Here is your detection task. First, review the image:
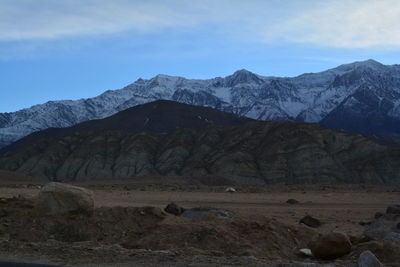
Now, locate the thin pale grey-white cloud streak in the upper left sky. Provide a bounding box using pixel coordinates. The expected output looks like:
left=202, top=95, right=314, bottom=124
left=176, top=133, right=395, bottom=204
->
left=0, top=0, right=193, bottom=41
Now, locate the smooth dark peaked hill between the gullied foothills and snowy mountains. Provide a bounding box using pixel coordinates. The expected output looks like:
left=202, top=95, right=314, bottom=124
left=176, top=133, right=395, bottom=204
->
left=0, top=100, right=253, bottom=154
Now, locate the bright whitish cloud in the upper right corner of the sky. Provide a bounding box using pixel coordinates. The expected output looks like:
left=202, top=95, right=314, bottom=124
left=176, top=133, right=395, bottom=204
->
left=264, top=0, right=400, bottom=48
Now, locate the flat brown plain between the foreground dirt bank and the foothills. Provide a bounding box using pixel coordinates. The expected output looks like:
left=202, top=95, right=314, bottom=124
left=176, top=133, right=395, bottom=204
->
left=0, top=184, right=400, bottom=238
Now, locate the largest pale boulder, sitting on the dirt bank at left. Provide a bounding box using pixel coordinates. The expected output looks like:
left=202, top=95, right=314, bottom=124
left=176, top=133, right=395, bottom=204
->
left=35, top=182, right=94, bottom=216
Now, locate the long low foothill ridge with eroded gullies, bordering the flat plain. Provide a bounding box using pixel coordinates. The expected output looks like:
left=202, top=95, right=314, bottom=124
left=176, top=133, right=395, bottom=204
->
left=0, top=122, right=400, bottom=184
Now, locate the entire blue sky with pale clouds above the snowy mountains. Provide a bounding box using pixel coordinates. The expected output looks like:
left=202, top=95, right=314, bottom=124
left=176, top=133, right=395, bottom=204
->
left=0, top=0, right=400, bottom=112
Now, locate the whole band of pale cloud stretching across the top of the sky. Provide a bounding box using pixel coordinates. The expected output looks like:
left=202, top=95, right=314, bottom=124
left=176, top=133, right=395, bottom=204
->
left=0, top=0, right=400, bottom=48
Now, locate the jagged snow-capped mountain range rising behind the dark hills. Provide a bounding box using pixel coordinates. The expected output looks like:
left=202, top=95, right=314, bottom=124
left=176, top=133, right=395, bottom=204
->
left=0, top=60, right=400, bottom=149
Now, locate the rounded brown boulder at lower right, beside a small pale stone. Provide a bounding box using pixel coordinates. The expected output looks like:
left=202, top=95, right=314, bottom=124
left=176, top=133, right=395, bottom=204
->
left=309, top=232, right=351, bottom=260
